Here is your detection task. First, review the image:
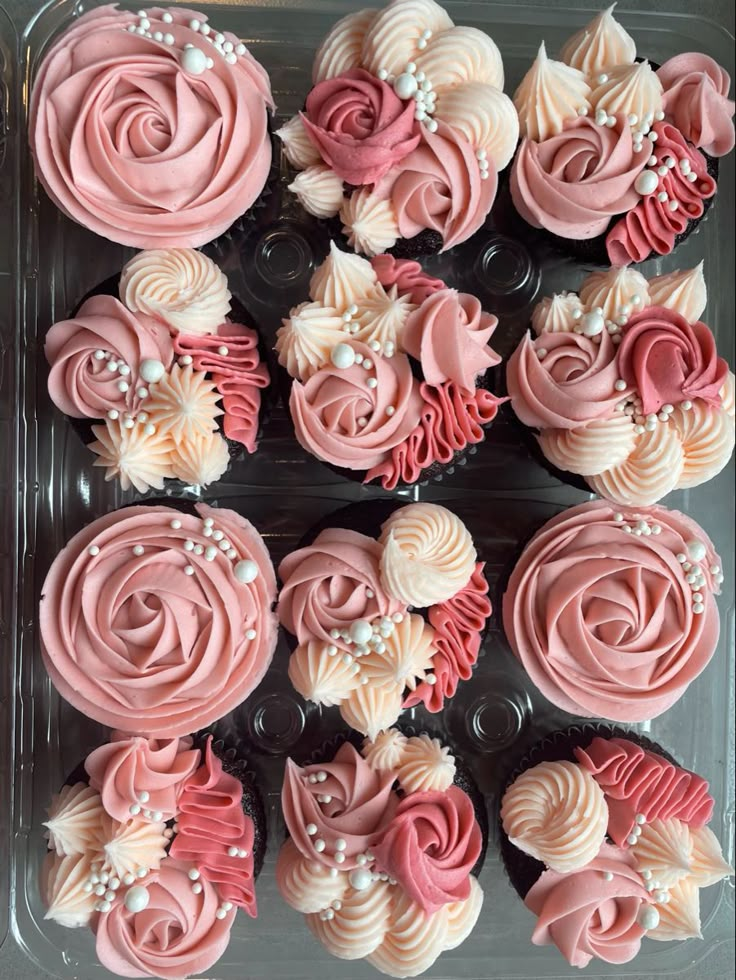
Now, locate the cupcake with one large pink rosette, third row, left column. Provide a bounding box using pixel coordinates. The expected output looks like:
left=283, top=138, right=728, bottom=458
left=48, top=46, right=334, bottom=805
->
left=39, top=504, right=277, bottom=737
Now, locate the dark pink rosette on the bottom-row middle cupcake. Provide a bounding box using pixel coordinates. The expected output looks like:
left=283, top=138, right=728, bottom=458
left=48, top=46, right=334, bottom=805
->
left=371, top=786, right=483, bottom=914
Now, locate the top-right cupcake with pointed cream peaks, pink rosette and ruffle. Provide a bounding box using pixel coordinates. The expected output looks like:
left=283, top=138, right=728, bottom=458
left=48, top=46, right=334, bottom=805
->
left=511, top=5, right=734, bottom=265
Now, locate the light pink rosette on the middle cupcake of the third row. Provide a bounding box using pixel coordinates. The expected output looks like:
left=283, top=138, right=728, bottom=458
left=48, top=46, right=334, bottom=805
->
left=277, top=527, right=406, bottom=644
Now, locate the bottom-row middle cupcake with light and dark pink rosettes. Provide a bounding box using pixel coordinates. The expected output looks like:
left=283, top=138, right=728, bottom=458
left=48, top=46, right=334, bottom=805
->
left=276, top=729, right=487, bottom=977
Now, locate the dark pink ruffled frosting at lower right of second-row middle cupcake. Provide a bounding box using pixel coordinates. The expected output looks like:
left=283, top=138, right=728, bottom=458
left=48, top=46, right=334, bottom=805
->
left=364, top=382, right=506, bottom=490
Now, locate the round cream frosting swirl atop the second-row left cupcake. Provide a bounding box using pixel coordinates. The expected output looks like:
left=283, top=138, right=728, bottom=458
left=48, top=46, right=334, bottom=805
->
left=120, top=248, right=231, bottom=334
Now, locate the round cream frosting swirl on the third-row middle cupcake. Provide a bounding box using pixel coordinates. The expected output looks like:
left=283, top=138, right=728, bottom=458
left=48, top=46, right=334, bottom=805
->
left=379, top=503, right=477, bottom=608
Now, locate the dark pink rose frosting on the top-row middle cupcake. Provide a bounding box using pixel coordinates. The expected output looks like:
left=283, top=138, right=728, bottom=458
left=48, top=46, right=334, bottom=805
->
left=302, top=68, right=419, bottom=185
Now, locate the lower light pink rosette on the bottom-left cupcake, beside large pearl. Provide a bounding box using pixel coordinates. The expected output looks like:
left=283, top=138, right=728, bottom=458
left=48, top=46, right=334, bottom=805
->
left=93, top=858, right=236, bottom=980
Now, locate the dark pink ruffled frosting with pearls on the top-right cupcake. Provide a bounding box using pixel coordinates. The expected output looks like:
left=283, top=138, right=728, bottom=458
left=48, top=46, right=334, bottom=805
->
left=604, top=122, right=716, bottom=265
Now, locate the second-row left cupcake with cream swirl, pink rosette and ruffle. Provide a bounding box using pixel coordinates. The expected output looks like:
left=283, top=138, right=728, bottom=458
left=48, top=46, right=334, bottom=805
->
left=45, top=248, right=270, bottom=493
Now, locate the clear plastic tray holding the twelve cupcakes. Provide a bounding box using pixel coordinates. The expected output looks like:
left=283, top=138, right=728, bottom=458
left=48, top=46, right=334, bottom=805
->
left=8, top=0, right=735, bottom=980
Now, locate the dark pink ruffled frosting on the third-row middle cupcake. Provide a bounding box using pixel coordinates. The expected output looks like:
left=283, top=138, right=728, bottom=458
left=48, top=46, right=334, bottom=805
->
left=404, top=562, right=492, bottom=712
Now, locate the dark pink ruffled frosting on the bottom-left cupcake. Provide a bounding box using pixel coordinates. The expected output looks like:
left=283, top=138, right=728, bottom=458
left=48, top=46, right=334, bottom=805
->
left=169, top=736, right=257, bottom=918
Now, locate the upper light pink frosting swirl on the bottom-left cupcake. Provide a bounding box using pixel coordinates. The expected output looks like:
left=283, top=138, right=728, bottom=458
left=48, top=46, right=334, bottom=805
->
left=84, top=732, right=201, bottom=823
